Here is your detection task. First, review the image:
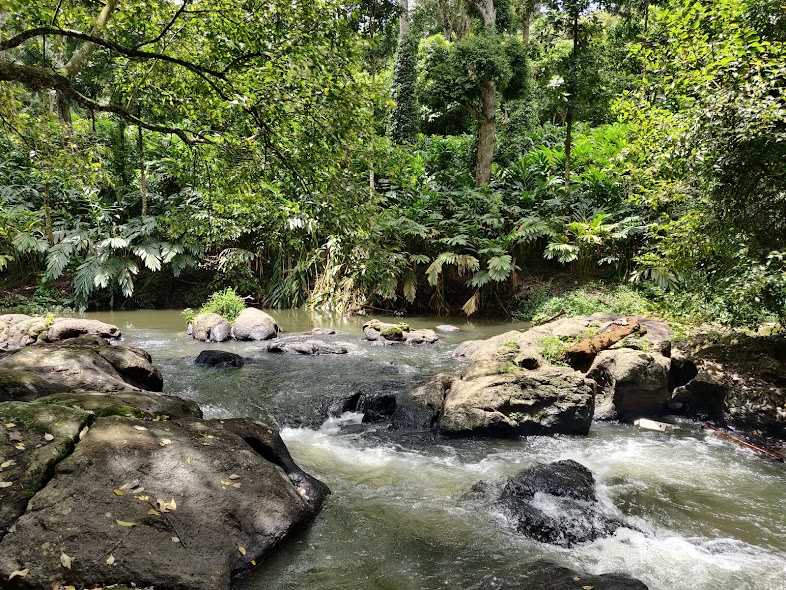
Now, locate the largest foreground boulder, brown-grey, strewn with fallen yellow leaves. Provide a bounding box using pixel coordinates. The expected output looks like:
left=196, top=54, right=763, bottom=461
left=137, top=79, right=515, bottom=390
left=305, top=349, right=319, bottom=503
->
left=0, top=417, right=328, bottom=590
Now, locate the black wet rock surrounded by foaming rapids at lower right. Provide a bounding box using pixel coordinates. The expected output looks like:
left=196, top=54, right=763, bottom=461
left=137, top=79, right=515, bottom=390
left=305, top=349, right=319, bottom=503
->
left=497, top=459, right=621, bottom=547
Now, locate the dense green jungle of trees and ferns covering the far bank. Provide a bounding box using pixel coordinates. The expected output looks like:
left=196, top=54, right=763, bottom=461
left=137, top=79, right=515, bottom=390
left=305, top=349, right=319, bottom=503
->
left=0, top=0, right=786, bottom=325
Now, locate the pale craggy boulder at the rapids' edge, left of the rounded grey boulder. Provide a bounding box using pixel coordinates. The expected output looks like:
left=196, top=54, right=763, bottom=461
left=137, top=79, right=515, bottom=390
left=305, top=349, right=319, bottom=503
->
left=439, top=365, right=595, bottom=436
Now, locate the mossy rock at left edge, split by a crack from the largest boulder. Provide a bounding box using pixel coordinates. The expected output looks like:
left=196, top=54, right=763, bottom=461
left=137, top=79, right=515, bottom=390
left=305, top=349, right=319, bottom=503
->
left=0, top=402, right=91, bottom=540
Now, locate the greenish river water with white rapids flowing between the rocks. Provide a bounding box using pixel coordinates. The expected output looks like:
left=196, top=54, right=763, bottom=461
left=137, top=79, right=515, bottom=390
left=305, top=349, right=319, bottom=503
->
left=89, top=311, right=786, bottom=590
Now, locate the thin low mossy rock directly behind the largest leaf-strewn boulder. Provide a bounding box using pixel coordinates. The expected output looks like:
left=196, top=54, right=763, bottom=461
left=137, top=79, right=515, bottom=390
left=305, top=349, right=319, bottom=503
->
left=35, top=391, right=202, bottom=420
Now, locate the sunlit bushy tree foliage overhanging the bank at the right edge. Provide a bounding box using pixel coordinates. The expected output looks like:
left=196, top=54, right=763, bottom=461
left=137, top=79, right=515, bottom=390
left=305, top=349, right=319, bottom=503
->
left=619, top=0, right=786, bottom=325
